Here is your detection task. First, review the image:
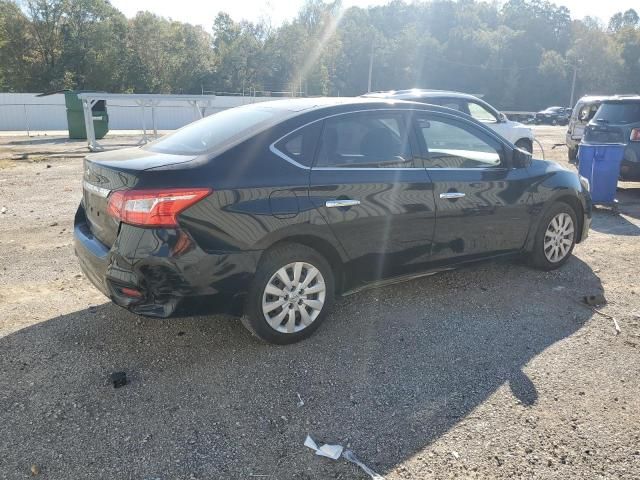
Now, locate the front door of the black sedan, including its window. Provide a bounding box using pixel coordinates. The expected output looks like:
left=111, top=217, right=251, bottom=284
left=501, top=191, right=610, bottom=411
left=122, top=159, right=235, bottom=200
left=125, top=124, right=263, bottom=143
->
left=415, top=113, right=531, bottom=261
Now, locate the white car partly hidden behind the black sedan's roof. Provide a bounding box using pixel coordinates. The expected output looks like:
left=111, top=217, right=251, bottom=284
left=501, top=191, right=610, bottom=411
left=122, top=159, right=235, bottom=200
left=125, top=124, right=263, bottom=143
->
left=363, top=88, right=534, bottom=153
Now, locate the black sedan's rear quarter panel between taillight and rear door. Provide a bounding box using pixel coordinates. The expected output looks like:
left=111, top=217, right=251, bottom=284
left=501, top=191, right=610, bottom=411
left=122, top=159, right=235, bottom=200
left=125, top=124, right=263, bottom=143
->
left=175, top=125, right=343, bottom=257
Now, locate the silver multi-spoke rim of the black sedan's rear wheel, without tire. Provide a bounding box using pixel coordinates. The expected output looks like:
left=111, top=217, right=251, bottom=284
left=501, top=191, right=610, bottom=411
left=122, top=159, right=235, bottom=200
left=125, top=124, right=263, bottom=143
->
left=262, top=262, right=327, bottom=333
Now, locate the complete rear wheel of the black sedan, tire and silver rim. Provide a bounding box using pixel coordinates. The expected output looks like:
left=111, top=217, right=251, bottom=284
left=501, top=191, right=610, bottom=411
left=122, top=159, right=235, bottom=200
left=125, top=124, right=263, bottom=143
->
left=242, top=243, right=335, bottom=345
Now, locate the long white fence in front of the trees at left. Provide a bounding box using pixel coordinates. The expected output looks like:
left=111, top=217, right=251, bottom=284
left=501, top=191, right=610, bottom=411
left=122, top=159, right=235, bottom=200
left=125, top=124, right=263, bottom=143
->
left=0, top=93, right=290, bottom=133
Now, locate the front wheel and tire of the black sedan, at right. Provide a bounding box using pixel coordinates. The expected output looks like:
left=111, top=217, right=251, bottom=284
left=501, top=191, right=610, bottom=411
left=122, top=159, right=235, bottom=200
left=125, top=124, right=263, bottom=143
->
left=529, top=202, right=578, bottom=270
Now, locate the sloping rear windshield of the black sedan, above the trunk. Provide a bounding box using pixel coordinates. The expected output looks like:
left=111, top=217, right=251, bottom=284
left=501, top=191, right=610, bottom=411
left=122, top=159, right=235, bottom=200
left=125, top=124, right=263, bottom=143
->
left=144, top=105, right=282, bottom=155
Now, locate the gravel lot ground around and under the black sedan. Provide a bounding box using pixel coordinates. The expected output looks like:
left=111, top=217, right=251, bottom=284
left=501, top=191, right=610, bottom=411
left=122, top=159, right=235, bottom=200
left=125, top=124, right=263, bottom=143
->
left=0, top=127, right=640, bottom=480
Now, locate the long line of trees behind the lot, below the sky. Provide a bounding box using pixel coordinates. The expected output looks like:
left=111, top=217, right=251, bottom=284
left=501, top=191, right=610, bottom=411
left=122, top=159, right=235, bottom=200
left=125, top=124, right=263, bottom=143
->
left=0, top=0, right=640, bottom=110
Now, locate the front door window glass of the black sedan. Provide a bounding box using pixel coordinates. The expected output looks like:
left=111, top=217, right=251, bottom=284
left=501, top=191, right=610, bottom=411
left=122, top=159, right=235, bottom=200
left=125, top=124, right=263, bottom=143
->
left=418, top=118, right=501, bottom=168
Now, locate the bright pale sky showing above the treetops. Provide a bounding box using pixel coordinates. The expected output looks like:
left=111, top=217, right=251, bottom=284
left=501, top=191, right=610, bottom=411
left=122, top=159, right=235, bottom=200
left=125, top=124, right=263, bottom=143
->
left=111, top=0, right=638, bottom=30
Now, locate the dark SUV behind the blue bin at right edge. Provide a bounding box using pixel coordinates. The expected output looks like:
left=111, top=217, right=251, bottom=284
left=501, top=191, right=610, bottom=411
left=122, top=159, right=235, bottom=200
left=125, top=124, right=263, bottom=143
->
left=582, top=95, right=640, bottom=181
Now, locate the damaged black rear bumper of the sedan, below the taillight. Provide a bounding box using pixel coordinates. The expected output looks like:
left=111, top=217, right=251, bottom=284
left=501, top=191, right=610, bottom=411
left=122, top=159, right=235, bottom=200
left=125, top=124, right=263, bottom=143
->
left=74, top=206, right=260, bottom=318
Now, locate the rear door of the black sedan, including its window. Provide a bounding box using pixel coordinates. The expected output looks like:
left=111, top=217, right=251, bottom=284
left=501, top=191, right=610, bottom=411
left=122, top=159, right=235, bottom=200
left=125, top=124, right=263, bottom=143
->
left=309, top=110, right=435, bottom=281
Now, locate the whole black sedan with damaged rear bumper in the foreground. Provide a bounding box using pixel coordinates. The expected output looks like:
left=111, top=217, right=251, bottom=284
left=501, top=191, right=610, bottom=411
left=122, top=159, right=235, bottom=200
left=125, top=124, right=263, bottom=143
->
left=75, top=98, right=591, bottom=344
